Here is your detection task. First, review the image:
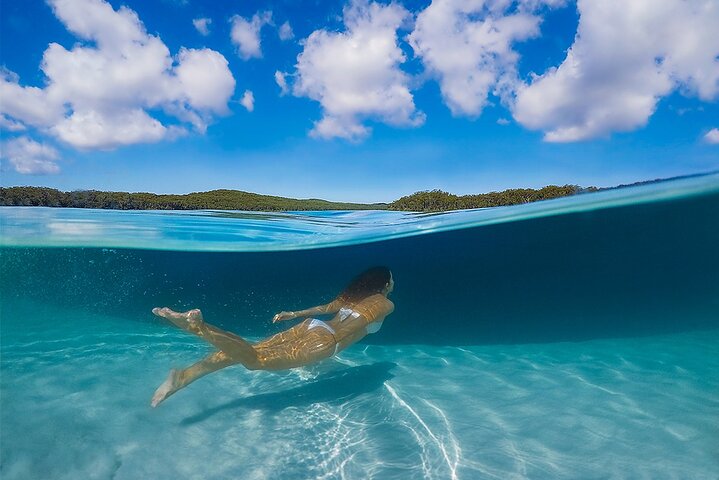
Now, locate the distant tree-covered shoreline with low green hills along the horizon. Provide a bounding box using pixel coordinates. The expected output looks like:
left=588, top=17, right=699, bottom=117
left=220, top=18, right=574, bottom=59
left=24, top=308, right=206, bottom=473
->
left=0, top=175, right=701, bottom=212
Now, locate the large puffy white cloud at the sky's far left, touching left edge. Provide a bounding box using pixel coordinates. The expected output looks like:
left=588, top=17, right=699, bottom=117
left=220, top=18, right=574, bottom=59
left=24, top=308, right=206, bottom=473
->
left=0, top=0, right=235, bottom=149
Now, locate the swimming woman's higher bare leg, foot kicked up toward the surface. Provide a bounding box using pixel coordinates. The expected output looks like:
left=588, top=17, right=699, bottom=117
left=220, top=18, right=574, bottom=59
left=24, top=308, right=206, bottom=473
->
left=152, top=307, right=259, bottom=370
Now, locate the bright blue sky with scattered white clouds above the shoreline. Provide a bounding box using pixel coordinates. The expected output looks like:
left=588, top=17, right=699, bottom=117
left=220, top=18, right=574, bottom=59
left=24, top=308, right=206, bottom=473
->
left=0, top=0, right=719, bottom=202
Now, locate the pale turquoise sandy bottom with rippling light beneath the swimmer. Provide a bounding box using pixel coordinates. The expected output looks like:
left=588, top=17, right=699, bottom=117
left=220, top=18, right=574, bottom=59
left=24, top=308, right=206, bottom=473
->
left=0, top=306, right=719, bottom=479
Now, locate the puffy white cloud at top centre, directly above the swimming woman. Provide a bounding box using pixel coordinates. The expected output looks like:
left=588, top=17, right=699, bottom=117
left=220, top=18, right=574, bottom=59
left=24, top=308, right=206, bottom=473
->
left=292, top=0, right=425, bottom=141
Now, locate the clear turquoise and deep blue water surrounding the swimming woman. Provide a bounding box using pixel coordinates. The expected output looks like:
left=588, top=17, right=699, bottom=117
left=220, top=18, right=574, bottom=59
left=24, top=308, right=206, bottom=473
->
left=0, top=175, right=719, bottom=479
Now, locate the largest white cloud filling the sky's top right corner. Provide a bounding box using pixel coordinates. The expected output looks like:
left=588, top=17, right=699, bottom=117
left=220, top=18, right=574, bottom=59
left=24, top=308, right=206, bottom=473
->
left=512, top=0, right=719, bottom=142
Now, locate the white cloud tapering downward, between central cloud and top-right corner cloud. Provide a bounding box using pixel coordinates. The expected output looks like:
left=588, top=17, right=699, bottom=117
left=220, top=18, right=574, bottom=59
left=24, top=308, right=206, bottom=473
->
left=409, top=0, right=544, bottom=117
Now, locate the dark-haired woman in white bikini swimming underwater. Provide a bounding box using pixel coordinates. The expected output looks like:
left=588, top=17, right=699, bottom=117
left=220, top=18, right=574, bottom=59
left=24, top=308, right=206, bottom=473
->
left=151, top=267, right=394, bottom=407
